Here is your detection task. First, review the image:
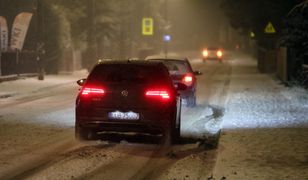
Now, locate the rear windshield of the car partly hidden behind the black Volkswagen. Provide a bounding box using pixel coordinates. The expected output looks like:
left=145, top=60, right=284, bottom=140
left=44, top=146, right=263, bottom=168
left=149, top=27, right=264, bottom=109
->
left=151, top=59, right=191, bottom=75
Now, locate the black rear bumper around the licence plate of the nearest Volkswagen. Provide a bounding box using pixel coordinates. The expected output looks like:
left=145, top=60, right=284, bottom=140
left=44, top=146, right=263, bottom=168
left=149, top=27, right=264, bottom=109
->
left=75, top=100, right=179, bottom=134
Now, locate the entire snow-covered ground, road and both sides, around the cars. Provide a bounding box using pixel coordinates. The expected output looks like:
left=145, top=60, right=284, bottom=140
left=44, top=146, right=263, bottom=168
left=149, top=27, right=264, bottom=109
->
left=0, top=51, right=308, bottom=180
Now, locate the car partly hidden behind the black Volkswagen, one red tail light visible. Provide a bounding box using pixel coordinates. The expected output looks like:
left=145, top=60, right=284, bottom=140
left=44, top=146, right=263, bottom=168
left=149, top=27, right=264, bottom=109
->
left=147, top=58, right=202, bottom=107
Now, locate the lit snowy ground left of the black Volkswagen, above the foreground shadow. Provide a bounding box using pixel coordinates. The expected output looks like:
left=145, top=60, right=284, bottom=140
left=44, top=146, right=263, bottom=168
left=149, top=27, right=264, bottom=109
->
left=0, top=70, right=88, bottom=128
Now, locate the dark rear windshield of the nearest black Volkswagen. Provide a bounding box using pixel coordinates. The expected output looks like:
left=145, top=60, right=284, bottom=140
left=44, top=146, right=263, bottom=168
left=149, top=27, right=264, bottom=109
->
left=88, top=64, right=168, bottom=84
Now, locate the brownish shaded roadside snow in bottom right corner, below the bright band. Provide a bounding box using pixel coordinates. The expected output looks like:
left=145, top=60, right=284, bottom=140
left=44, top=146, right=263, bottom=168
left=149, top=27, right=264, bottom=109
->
left=214, top=128, right=308, bottom=180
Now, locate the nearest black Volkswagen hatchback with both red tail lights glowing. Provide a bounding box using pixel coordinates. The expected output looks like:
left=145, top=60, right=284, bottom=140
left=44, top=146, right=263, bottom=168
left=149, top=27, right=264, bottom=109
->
left=75, top=60, right=186, bottom=142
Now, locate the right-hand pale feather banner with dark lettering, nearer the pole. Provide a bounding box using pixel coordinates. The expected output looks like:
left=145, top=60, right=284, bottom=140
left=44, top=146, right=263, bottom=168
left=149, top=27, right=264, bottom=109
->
left=10, top=12, right=33, bottom=51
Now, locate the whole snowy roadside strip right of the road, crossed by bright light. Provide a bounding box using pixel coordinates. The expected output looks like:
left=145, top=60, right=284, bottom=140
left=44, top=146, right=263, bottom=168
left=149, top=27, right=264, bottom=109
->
left=214, top=54, right=308, bottom=180
